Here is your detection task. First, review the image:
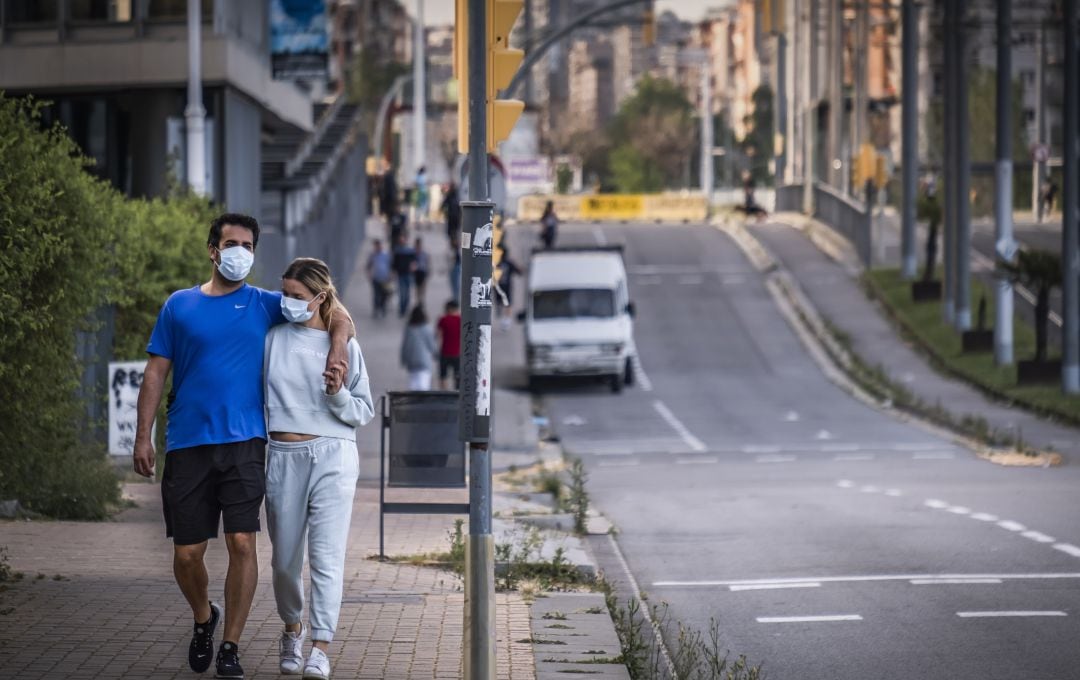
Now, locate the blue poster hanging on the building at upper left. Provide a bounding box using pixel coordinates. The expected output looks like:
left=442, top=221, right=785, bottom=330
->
left=270, top=0, right=329, bottom=80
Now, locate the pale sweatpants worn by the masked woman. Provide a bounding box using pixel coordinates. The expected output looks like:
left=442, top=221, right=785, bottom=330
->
left=266, top=437, right=360, bottom=642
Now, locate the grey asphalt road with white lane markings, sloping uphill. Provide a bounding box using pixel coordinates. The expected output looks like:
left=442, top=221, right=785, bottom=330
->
left=503, top=225, right=1080, bottom=680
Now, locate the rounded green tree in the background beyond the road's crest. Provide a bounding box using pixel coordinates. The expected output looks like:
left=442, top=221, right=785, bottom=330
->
left=608, top=77, right=694, bottom=193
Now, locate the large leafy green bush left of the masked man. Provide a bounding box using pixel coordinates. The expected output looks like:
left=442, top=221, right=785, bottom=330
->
left=0, top=93, right=217, bottom=519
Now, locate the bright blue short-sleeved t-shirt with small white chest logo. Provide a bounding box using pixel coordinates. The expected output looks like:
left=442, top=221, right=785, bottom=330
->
left=146, top=284, right=285, bottom=451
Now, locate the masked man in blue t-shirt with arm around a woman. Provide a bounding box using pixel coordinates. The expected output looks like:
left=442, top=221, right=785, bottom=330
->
left=134, top=214, right=352, bottom=678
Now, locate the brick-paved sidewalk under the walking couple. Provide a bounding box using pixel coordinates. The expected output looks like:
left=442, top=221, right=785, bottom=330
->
left=0, top=222, right=536, bottom=680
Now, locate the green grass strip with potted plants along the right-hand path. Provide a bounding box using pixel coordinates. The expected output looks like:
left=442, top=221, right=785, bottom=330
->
left=864, top=269, right=1080, bottom=425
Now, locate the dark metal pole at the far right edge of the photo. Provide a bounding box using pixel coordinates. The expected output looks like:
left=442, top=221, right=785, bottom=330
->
left=1062, top=0, right=1080, bottom=394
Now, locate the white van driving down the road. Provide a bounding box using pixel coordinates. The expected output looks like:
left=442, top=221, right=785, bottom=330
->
left=524, top=247, right=637, bottom=392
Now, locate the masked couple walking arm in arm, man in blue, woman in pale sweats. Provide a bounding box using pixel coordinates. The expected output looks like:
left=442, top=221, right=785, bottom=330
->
left=134, top=214, right=374, bottom=679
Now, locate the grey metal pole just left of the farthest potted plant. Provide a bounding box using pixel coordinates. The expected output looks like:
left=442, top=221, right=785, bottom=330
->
left=900, top=0, right=919, bottom=281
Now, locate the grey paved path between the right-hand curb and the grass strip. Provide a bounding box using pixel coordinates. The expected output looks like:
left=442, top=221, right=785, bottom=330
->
left=747, top=214, right=1080, bottom=460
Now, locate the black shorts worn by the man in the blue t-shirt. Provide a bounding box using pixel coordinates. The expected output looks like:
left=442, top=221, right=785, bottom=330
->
left=161, top=438, right=267, bottom=545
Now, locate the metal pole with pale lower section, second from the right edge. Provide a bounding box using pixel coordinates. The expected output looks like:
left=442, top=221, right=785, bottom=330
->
left=994, top=0, right=1015, bottom=366
